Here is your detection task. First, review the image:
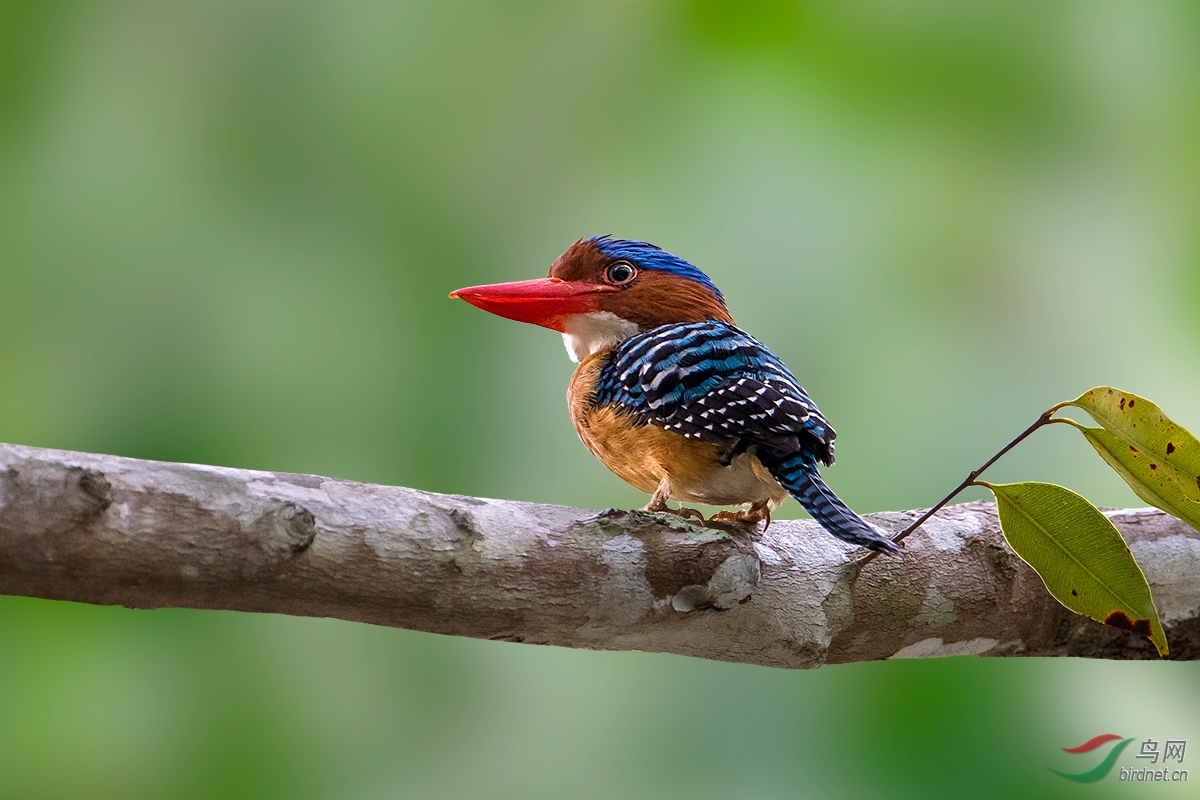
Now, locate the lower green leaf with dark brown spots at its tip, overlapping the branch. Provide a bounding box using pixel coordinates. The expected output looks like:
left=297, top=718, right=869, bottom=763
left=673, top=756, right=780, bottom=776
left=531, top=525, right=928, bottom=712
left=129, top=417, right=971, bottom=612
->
left=980, top=481, right=1166, bottom=656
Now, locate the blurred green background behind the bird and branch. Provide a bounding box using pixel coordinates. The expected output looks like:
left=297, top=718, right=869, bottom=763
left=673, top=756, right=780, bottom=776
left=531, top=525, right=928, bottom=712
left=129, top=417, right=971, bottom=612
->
left=0, top=0, right=1200, bottom=799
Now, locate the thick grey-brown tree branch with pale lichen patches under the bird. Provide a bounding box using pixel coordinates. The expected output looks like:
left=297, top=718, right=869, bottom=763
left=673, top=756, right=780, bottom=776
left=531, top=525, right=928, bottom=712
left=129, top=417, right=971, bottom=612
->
left=0, top=445, right=1200, bottom=667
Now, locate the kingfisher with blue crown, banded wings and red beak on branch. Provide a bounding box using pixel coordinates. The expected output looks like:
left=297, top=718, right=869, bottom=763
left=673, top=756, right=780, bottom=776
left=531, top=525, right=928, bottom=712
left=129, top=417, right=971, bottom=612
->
left=450, top=235, right=904, bottom=553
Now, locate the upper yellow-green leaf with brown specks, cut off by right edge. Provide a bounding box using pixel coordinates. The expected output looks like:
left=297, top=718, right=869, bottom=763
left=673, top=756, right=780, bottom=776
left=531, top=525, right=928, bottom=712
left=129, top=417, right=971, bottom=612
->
left=1060, top=386, right=1200, bottom=530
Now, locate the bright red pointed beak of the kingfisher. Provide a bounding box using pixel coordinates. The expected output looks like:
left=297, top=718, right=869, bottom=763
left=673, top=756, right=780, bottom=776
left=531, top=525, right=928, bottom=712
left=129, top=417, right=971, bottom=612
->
left=450, top=278, right=617, bottom=332
